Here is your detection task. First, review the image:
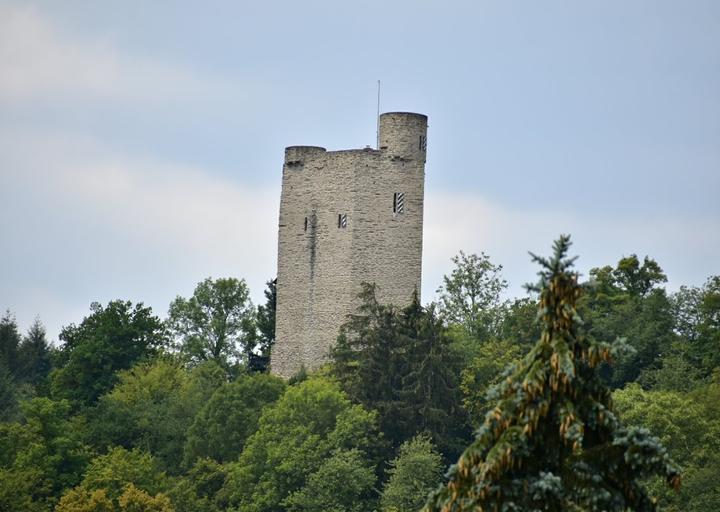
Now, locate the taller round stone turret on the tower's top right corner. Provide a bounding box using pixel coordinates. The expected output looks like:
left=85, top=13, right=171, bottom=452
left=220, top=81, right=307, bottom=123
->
left=379, top=112, right=427, bottom=162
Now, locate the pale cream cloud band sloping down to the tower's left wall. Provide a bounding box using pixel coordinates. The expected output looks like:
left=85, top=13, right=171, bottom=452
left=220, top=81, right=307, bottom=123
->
left=0, top=129, right=279, bottom=267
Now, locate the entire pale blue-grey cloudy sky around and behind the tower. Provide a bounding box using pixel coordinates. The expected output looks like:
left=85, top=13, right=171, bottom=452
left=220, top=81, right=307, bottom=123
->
left=0, top=0, right=720, bottom=338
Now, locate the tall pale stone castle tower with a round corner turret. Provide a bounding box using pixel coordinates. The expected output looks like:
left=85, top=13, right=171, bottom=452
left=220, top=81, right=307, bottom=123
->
left=271, top=112, right=427, bottom=378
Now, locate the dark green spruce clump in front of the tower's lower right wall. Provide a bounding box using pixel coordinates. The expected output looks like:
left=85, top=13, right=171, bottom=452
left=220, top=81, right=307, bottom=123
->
left=332, top=284, right=468, bottom=457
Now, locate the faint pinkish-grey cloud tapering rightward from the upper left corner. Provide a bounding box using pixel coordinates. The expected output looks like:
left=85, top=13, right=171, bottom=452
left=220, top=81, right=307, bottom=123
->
left=0, top=5, right=246, bottom=102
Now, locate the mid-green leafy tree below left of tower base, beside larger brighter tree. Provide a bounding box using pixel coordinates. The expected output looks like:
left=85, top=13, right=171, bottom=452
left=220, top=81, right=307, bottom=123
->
left=185, top=374, right=285, bottom=466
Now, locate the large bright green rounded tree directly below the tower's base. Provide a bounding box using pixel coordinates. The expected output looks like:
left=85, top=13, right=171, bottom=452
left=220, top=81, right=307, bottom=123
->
left=221, top=377, right=381, bottom=512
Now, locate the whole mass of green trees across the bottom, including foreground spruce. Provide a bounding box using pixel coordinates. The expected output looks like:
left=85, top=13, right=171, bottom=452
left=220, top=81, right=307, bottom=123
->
left=0, top=241, right=720, bottom=512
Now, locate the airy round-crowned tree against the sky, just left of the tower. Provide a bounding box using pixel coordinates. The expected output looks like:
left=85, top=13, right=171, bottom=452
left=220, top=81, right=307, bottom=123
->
left=168, top=278, right=256, bottom=368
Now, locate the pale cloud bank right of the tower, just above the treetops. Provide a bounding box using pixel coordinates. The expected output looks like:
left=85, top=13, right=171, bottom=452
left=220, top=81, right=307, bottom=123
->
left=423, top=191, right=720, bottom=301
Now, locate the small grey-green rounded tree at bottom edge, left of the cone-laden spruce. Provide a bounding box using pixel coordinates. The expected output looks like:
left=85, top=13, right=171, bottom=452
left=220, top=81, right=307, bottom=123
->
left=380, top=435, right=443, bottom=512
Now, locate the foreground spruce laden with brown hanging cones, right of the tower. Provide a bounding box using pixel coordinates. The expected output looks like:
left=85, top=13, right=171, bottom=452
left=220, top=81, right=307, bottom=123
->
left=424, top=236, right=681, bottom=512
